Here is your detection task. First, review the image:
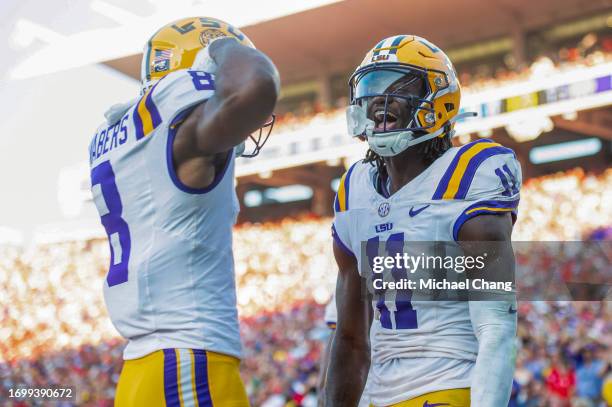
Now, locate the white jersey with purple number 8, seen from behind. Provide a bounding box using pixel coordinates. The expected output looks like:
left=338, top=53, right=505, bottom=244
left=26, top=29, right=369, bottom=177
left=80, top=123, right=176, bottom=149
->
left=89, top=70, right=241, bottom=359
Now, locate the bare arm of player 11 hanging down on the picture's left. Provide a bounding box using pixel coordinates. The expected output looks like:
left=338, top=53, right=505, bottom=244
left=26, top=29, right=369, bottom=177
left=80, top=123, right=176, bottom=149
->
left=325, top=242, right=371, bottom=407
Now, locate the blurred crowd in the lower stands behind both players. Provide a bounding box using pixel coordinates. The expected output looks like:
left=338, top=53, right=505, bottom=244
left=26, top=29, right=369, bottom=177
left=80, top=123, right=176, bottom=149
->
left=0, top=169, right=612, bottom=407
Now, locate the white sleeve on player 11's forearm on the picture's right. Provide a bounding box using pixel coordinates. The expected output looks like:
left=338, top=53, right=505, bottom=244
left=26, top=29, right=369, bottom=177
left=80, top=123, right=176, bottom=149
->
left=470, top=301, right=516, bottom=407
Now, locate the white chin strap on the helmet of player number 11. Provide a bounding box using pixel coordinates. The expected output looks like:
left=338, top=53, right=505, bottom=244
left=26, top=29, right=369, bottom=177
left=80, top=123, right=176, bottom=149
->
left=365, top=112, right=477, bottom=157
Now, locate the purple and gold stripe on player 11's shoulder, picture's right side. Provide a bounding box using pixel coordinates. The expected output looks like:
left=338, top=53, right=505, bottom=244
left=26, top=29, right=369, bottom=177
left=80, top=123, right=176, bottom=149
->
left=432, top=139, right=514, bottom=200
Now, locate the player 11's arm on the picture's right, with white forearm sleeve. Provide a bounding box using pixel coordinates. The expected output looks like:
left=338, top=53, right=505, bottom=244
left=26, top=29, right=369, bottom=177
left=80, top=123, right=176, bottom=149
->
left=458, top=213, right=517, bottom=407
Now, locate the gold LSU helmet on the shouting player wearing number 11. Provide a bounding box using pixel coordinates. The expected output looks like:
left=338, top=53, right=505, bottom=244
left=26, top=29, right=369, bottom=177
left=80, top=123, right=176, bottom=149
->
left=347, top=35, right=473, bottom=157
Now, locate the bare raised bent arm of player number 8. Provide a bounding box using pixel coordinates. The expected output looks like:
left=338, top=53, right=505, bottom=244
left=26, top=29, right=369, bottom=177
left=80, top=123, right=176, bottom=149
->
left=178, top=37, right=280, bottom=155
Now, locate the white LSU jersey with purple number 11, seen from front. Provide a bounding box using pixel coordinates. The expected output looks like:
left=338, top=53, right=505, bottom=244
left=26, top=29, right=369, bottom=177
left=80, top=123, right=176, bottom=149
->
left=332, top=139, right=521, bottom=405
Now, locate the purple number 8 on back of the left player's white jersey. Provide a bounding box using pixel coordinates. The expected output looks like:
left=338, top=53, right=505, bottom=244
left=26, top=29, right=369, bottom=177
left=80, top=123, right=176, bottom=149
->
left=91, top=161, right=132, bottom=287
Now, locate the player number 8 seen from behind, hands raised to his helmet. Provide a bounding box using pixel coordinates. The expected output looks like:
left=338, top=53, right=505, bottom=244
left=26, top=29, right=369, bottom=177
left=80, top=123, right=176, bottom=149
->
left=89, top=17, right=279, bottom=407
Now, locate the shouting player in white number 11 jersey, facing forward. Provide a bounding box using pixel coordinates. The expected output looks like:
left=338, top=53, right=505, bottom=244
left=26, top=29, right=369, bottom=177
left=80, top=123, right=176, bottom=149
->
left=326, top=35, right=521, bottom=407
